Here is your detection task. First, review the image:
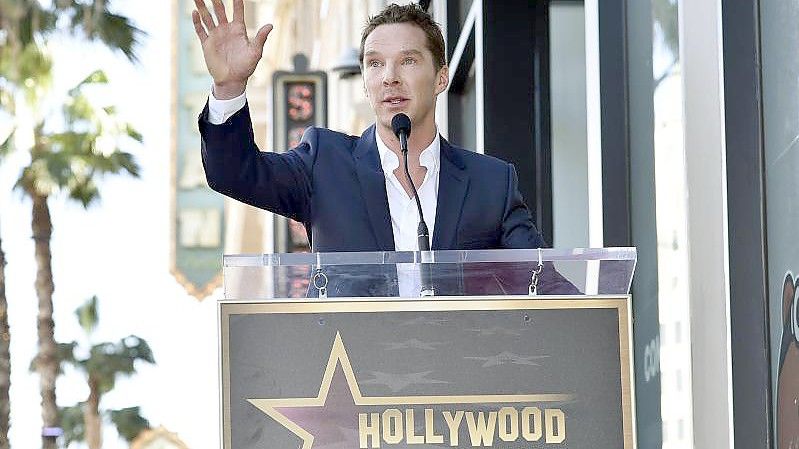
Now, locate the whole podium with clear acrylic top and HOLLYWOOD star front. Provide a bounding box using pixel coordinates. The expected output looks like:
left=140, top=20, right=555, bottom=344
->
left=219, top=248, right=636, bottom=449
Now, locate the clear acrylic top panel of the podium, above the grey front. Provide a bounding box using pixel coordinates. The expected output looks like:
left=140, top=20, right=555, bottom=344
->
left=223, top=248, right=636, bottom=300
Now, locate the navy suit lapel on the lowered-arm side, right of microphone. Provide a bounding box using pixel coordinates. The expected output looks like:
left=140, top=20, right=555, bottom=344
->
left=432, top=137, right=469, bottom=250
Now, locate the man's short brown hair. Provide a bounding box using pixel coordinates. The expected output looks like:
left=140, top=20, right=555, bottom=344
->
left=358, top=3, right=447, bottom=71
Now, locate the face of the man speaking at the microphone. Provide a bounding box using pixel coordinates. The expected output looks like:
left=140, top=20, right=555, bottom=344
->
left=363, top=23, right=449, bottom=134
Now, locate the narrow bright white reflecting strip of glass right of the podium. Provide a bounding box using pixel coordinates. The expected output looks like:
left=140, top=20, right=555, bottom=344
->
left=652, top=0, right=693, bottom=449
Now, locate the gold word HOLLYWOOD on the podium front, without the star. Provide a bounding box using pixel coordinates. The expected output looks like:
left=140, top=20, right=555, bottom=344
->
left=358, top=407, right=566, bottom=449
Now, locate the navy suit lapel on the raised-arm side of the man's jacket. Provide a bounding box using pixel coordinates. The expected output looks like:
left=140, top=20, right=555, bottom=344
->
left=353, top=125, right=394, bottom=251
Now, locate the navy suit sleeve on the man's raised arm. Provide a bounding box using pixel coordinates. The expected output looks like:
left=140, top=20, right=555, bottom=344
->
left=199, top=100, right=318, bottom=224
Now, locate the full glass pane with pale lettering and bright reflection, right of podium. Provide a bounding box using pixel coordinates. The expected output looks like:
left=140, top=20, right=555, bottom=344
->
left=626, top=0, right=692, bottom=449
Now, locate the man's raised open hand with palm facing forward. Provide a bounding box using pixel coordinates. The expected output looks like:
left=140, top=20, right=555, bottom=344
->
left=191, top=0, right=272, bottom=99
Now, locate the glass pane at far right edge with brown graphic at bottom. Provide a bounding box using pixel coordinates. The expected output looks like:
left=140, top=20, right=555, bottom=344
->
left=760, top=1, right=799, bottom=449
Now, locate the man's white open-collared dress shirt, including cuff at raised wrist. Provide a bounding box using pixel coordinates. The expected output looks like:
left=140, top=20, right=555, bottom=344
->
left=208, top=91, right=441, bottom=297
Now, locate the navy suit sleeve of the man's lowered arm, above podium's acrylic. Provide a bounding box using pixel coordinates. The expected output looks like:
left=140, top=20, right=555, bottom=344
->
left=501, top=164, right=547, bottom=249
